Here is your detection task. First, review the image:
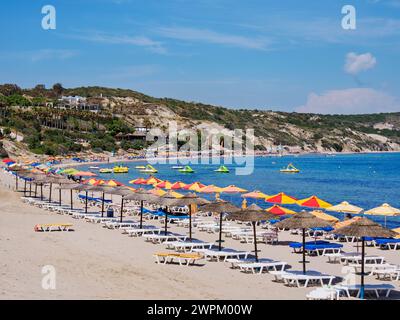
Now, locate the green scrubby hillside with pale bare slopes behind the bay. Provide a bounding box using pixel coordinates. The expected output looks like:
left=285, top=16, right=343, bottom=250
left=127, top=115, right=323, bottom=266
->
left=0, top=84, right=400, bottom=154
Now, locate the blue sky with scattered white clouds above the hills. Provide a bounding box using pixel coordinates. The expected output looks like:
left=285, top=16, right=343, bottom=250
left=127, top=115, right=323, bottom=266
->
left=0, top=0, right=400, bottom=113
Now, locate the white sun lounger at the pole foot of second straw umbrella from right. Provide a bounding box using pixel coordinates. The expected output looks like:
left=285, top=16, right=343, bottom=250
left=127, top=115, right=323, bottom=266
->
left=270, top=271, right=335, bottom=288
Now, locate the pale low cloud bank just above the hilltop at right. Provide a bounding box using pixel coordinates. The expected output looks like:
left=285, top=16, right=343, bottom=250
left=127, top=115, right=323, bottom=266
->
left=296, top=88, right=400, bottom=114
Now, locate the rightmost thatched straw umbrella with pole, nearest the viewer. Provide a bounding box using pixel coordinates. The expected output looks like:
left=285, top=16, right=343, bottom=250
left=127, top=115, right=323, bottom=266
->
left=332, top=218, right=397, bottom=299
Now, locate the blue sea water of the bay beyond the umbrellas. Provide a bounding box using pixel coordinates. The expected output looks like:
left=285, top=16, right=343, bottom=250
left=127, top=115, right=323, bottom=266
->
left=78, top=153, right=400, bottom=228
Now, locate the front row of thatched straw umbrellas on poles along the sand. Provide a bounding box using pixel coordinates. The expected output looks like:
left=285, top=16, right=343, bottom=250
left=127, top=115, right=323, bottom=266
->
left=6, top=168, right=397, bottom=298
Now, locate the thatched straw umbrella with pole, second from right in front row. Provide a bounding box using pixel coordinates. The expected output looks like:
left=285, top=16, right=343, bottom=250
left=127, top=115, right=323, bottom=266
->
left=274, top=211, right=332, bottom=273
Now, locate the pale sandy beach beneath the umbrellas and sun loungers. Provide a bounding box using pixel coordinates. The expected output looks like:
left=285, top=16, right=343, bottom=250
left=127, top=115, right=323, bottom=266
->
left=0, top=171, right=400, bottom=299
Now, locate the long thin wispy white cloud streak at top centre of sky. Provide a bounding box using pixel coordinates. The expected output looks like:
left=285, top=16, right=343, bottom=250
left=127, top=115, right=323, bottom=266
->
left=157, top=27, right=270, bottom=50
